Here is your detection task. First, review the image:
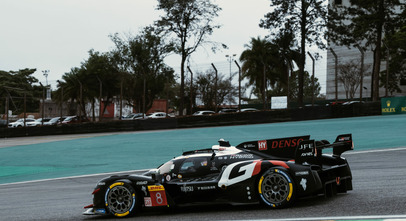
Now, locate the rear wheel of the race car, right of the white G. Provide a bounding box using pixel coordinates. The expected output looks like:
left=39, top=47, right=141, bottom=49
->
left=258, top=168, right=295, bottom=208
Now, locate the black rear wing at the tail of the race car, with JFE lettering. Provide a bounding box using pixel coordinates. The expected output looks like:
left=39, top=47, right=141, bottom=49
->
left=295, top=134, right=354, bottom=164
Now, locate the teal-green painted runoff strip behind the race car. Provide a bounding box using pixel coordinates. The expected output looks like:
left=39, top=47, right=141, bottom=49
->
left=0, top=115, right=406, bottom=184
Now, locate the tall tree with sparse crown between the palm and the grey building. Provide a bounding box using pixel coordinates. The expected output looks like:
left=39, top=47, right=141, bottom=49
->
left=260, top=0, right=327, bottom=106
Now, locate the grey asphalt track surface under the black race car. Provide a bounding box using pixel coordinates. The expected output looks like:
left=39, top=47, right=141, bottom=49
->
left=0, top=148, right=406, bottom=221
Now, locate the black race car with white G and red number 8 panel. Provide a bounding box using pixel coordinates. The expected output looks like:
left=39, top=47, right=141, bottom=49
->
left=84, top=134, right=353, bottom=217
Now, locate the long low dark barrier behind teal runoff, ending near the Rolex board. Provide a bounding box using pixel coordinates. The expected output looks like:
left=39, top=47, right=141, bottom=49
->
left=0, top=102, right=381, bottom=138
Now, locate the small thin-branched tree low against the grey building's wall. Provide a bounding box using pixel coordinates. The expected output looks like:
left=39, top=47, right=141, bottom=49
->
left=338, top=60, right=369, bottom=99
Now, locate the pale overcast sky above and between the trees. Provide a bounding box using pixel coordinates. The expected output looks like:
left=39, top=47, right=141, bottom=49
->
left=0, top=0, right=326, bottom=93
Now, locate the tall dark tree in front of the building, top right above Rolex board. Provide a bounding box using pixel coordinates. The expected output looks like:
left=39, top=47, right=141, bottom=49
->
left=328, top=0, right=404, bottom=101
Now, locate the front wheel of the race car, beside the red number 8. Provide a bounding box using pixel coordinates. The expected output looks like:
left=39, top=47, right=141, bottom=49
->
left=105, top=181, right=138, bottom=217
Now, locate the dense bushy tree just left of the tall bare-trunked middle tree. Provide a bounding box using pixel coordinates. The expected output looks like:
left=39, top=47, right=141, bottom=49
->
left=111, top=26, right=174, bottom=113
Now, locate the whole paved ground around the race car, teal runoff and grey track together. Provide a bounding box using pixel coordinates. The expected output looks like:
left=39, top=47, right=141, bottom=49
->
left=0, top=115, right=406, bottom=220
